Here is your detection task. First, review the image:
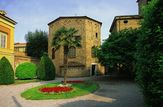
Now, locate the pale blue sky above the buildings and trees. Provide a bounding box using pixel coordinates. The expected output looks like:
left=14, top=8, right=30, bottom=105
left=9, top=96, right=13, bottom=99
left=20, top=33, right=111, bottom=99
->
left=0, top=0, right=138, bottom=42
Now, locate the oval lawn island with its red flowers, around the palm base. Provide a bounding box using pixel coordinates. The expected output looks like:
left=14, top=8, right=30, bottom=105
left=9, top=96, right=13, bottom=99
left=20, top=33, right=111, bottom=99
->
left=21, top=81, right=99, bottom=100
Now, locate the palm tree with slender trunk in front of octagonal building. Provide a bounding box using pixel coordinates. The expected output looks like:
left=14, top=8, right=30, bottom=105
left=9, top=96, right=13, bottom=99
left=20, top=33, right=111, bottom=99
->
left=52, top=27, right=81, bottom=84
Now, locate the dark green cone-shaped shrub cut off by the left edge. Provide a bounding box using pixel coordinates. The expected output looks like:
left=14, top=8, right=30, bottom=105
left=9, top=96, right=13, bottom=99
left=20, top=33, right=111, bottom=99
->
left=0, top=57, right=15, bottom=84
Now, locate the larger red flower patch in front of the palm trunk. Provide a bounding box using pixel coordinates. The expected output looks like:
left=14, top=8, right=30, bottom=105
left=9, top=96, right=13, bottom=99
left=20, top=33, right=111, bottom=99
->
left=39, top=86, right=73, bottom=93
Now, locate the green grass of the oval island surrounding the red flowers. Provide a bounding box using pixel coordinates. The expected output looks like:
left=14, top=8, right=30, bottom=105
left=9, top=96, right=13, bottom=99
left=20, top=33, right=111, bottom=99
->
left=21, top=82, right=99, bottom=100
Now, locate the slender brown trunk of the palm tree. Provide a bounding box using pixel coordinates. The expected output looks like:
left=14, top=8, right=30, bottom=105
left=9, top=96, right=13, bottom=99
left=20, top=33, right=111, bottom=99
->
left=63, top=46, right=68, bottom=84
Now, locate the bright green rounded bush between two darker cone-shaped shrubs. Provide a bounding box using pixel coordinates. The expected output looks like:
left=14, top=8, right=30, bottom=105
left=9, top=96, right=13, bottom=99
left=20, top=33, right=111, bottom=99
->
left=15, top=62, right=37, bottom=79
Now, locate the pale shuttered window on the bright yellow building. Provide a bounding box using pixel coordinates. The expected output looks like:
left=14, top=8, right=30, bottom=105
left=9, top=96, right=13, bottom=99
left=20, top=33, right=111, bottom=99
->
left=0, top=32, right=7, bottom=48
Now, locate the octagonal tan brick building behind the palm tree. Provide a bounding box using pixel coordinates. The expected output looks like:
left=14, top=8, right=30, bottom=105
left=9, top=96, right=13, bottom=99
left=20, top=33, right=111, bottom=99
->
left=48, top=16, right=104, bottom=77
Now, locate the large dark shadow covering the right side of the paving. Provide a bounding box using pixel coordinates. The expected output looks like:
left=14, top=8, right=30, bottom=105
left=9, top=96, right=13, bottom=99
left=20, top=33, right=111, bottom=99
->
left=61, top=77, right=144, bottom=107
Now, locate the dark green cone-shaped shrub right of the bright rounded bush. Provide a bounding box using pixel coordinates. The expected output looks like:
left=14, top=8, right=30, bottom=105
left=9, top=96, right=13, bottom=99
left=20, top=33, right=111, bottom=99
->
left=37, top=53, right=55, bottom=80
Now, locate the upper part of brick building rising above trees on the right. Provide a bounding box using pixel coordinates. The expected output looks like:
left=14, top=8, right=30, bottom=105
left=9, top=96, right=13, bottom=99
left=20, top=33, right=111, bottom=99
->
left=110, top=15, right=142, bottom=32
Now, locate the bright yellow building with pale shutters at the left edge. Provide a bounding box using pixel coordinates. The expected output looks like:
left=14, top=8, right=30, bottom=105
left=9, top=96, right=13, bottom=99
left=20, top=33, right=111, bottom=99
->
left=0, top=11, right=16, bottom=66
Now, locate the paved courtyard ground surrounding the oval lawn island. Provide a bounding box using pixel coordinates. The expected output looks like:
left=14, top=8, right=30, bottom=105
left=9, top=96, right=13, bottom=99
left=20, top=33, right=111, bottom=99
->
left=0, top=78, right=143, bottom=107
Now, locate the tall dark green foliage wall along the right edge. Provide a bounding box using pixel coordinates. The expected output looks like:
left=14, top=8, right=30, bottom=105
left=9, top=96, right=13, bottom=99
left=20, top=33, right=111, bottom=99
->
left=136, top=0, right=163, bottom=107
